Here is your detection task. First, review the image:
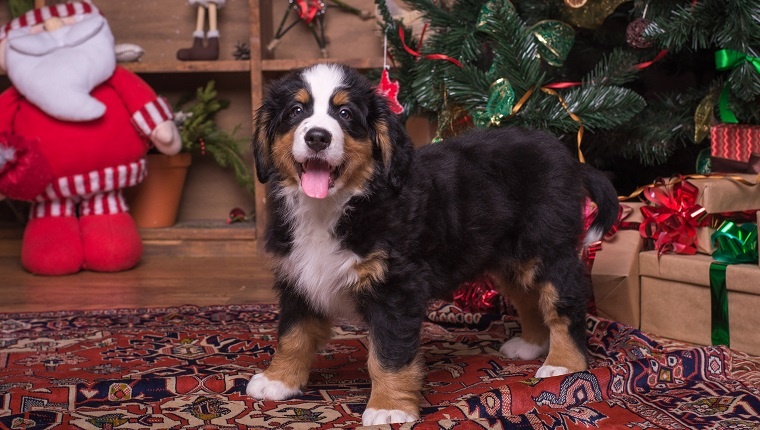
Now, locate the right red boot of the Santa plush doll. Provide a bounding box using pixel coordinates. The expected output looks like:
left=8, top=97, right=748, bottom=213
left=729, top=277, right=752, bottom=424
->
left=79, top=212, right=142, bottom=272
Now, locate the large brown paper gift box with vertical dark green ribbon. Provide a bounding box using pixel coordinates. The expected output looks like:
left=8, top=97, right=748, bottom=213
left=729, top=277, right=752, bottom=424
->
left=639, top=251, right=760, bottom=355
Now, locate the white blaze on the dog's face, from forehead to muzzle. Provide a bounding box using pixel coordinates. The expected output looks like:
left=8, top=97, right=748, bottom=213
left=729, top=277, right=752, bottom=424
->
left=293, top=64, right=344, bottom=167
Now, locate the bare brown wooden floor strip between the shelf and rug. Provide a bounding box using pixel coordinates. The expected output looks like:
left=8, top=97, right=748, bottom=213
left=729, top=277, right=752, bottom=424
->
left=0, top=255, right=276, bottom=312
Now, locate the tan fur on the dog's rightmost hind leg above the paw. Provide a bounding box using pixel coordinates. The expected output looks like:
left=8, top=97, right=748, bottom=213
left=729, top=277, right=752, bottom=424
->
left=538, top=282, right=588, bottom=372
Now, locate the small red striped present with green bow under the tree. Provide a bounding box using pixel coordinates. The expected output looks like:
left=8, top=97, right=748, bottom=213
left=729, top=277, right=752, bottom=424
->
left=710, top=124, right=760, bottom=166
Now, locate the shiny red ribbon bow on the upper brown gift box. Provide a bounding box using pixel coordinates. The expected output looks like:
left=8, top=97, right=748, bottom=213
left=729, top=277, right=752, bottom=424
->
left=639, top=178, right=707, bottom=255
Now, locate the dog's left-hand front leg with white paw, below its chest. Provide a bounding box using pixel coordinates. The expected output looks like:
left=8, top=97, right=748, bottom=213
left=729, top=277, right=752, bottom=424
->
left=245, top=293, right=331, bottom=400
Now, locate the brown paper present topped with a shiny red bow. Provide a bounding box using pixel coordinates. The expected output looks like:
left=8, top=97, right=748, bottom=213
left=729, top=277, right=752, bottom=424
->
left=640, top=173, right=760, bottom=255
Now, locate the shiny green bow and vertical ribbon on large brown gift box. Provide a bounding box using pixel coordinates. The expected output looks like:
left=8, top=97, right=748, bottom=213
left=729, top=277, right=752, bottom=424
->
left=710, top=221, right=758, bottom=346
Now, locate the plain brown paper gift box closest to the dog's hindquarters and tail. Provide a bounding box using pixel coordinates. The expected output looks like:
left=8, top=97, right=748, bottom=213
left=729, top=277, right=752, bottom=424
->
left=591, top=202, right=643, bottom=328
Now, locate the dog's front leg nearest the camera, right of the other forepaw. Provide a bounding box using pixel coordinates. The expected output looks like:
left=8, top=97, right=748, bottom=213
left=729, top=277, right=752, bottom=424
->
left=362, top=304, right=424, bottom=425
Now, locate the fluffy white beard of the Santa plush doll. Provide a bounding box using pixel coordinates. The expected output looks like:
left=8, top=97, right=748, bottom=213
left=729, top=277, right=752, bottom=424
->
left=6, top=16, right=116, bottom=121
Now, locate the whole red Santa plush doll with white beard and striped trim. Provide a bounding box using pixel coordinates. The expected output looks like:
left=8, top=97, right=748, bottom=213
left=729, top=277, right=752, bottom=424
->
left=0, top=2, right=181, bottom=275
